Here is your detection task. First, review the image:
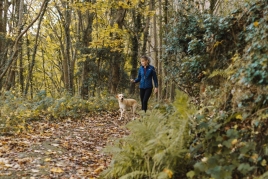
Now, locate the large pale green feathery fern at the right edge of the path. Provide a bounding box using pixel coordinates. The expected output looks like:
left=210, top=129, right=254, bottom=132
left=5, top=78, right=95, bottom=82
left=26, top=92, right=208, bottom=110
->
left=101, top=91, right=195, bottom=178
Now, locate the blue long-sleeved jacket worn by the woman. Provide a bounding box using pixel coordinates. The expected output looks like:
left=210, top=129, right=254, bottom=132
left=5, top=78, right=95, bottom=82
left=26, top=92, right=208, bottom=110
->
left=135, top=65, right=158, bottom=89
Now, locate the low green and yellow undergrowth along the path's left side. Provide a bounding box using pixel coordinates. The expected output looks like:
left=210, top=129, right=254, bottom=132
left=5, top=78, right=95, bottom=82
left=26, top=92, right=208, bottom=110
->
left=0, top=91, right=118, bottom=134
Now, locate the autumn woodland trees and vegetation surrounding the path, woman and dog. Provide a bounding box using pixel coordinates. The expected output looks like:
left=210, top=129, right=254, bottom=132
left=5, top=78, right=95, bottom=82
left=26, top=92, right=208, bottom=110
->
left=0, top=0, right=268, bottom=179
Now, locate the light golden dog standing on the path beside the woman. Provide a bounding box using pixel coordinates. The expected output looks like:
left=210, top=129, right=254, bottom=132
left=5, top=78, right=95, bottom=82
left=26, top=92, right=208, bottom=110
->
left=116, top=94, right=138, bottom=120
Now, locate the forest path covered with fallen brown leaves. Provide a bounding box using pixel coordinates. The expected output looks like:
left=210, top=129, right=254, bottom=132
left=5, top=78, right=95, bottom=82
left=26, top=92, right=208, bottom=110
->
left=0, top=112, right=128, bottom=179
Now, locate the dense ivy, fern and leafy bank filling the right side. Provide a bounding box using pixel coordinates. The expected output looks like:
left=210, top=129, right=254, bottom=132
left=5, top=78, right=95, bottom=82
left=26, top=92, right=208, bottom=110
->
left=103, top=1, right=268, bottom=179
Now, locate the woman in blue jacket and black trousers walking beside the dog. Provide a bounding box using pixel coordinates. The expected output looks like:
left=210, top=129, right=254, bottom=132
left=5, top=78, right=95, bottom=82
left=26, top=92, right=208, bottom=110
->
left=131, top=56, right=158, bottom=112
